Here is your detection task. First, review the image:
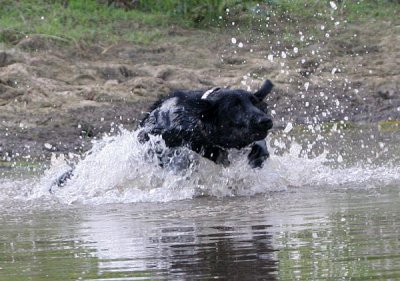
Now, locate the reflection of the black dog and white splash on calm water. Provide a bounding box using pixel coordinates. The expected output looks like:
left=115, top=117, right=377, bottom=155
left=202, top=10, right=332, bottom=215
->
left=71, top=199, right=277, bottom=280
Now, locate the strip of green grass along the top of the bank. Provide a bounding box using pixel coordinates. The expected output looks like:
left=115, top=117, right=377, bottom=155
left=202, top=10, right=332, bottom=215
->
left=0, top=0, right=400, bottom=44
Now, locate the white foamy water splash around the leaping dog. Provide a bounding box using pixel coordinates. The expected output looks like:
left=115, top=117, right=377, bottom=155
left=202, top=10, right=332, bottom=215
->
left=0, top=126, right=400, bottom=205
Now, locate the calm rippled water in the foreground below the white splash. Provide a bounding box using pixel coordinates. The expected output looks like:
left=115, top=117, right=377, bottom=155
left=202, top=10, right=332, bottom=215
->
left=0, top=186, right=400, bottom=280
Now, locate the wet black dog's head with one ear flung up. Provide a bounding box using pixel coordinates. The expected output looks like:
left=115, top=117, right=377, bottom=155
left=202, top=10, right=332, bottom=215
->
left=201, top=80, right=273, bottom=148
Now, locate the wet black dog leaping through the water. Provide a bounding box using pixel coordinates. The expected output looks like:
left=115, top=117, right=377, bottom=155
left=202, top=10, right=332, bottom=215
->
left=139, top=77, right=273, bottom=168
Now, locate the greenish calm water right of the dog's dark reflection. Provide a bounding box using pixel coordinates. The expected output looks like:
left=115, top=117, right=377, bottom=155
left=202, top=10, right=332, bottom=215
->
left=276, top=185, right=400, bottom=280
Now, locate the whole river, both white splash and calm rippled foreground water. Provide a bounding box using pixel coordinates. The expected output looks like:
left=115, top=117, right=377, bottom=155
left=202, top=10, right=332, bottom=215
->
left=0, top=124, right=400, bottom=280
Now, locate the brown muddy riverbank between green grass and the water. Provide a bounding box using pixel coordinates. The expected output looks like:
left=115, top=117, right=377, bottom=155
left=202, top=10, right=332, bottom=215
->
left=0, top=22, right=400, bottom=161
